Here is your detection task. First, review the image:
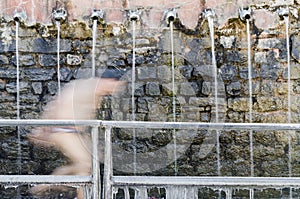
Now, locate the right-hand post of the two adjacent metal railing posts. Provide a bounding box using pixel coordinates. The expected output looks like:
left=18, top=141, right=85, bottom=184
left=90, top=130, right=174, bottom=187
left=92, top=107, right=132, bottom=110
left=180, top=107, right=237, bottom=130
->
left=104, top=126, right=113, bottom=199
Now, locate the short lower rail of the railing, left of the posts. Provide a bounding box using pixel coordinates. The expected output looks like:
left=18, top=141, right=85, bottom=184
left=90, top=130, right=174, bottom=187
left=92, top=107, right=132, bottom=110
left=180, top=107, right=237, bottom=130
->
left=0, top=175, right=92, bottom=184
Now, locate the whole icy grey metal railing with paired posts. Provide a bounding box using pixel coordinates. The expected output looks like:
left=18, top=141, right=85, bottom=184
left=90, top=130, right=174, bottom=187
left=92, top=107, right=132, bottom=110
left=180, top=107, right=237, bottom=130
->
left=0, top=119, right=300, bottom=199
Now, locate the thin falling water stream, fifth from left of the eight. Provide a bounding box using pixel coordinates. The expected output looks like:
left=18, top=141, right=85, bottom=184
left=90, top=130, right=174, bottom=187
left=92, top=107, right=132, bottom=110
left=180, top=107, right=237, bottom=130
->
left=170, top=20, right=177, bottom=175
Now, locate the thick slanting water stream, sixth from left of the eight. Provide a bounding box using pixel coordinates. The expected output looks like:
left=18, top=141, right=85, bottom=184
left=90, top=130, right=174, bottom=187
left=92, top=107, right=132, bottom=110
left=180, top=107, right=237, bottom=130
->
left=207, top=16, right=221, bottom=175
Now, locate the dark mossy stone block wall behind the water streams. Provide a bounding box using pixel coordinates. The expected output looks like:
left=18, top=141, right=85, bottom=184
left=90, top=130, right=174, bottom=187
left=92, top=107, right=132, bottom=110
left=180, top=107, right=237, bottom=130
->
left=0, top=1, right=300, bottom=197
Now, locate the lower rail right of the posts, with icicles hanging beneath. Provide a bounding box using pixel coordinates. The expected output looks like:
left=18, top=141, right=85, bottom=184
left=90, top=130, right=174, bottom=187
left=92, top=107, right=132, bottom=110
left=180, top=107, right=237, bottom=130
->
left=112, top=176, right=300, bottom=188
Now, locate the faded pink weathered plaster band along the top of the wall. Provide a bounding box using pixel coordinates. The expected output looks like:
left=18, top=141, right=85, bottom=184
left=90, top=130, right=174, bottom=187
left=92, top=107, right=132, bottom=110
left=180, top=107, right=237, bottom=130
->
left=0, top=0, right=299, bottom=28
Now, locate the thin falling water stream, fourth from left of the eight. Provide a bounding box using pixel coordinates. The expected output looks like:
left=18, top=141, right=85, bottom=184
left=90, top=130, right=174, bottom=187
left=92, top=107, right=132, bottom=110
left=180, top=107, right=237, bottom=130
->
left=131, top=20, right=137, bottom=174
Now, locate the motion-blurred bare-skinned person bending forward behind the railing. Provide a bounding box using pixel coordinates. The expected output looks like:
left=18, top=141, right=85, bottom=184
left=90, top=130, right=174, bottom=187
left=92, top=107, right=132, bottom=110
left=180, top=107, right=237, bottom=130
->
left=29, top=78, right=124, bottom=199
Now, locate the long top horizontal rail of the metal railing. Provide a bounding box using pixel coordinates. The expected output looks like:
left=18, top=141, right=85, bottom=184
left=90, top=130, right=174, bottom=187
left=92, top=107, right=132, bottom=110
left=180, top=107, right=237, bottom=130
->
left=0, top=119, right=300, bottom=131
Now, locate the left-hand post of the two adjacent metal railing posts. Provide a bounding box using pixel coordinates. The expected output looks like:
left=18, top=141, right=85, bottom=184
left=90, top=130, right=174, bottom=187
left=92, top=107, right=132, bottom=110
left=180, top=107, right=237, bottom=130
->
left=92, top=126, right=101, bottom=199
